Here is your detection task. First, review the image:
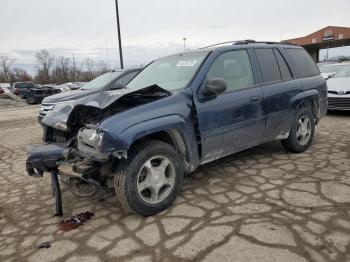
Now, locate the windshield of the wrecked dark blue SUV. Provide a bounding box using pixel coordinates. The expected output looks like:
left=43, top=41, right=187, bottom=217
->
left=127, top=52, right=208, bottom=91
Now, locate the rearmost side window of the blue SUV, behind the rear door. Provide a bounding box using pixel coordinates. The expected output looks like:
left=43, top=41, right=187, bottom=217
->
left=285, top=48, right=319, bottom=77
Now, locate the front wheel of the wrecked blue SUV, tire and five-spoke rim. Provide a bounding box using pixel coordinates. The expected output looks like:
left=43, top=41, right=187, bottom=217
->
left=114, top=140, right=184, bottom=216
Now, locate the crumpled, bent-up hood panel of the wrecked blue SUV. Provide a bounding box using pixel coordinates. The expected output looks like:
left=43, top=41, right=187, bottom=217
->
left=41, top=85, right=171, bottom=130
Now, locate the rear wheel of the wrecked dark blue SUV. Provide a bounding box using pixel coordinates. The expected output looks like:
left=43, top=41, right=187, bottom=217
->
left=281, top=107, right=315, bottom=153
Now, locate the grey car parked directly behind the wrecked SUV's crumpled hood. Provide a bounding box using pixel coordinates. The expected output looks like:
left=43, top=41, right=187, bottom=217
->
left=38, top=69, right=140, bottom=122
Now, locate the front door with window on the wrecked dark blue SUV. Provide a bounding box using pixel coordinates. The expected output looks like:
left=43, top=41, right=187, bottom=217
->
left=195, top=50, right=265, bottom=162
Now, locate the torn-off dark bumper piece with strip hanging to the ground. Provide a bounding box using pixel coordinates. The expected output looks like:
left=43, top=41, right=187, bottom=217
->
left=26, top=144, right=67, bottom=216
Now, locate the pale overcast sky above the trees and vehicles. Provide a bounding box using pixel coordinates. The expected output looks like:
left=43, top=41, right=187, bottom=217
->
left=0, top=0, right=350, bottom=73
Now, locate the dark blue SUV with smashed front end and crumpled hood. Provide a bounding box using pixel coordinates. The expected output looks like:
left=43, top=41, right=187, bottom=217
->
left=27, top=40, right=327, bottom=216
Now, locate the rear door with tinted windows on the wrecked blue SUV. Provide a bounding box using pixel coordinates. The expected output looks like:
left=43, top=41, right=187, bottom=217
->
left=255, top=48, right=301, bottom=140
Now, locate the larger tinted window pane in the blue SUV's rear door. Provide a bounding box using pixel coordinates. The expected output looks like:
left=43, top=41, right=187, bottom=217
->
left=255, top=48, right=282, bottom=82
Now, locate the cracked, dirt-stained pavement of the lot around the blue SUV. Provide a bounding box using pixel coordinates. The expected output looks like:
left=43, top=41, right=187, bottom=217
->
left=0, top=107, right=350, bottom=262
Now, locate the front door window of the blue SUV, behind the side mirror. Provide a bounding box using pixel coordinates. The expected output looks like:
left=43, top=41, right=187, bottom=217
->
left=207, top=50, right=254, bottom=92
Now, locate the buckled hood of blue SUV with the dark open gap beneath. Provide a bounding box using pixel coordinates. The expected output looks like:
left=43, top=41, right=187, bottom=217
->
left=42, top=85, right=171, bottom=143
